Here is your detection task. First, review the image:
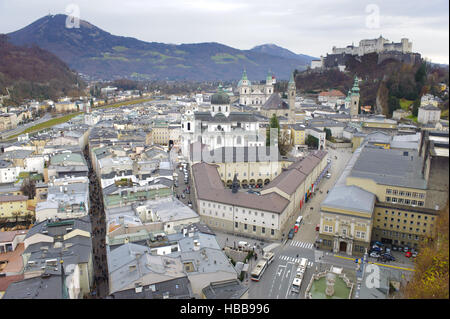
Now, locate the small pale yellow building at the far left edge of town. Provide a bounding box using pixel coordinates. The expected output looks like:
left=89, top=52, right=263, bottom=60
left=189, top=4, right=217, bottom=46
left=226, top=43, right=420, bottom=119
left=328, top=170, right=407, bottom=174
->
left=0, top=195, right=34, bottom=221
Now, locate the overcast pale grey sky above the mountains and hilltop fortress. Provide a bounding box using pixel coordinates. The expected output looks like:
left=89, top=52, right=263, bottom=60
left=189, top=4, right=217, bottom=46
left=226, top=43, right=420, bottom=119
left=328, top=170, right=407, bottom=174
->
left=0, top=0, right=449, bottom=64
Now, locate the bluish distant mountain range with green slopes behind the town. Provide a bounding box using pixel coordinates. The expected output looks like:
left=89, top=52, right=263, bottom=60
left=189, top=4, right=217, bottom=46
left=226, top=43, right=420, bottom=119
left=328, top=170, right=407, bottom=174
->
left=8, top=14, right=315, bottom=81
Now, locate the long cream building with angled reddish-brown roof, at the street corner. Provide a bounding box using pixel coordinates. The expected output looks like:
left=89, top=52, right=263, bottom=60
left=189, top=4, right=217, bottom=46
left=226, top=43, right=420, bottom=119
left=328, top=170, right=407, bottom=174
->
left=192, top=151, right=327, bottom=239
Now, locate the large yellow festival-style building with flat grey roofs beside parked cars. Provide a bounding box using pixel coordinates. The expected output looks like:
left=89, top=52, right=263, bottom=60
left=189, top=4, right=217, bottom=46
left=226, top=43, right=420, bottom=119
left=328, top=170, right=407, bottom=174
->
left=320, top=141, right=436, bottom=255
